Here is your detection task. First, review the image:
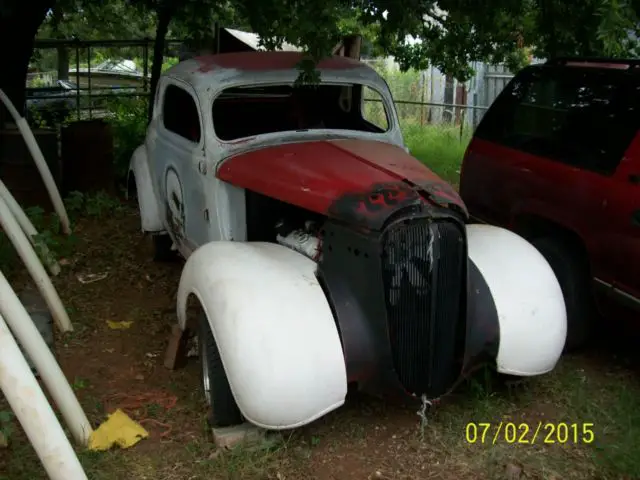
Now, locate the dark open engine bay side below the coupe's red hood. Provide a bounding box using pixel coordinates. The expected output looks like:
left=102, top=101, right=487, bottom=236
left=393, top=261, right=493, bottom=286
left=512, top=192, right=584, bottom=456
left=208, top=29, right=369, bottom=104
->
left=245, top=190, right=327, bottom=261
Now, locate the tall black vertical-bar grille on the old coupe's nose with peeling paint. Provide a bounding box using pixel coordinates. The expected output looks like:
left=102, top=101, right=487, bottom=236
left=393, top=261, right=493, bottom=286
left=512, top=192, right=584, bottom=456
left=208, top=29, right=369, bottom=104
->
left=382, top=219, right=466, bottom=396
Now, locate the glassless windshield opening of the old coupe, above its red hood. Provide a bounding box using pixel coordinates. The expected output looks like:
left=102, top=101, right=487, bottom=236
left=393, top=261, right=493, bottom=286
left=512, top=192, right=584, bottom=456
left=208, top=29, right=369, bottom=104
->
left=212, top=84, right=389, bottom=141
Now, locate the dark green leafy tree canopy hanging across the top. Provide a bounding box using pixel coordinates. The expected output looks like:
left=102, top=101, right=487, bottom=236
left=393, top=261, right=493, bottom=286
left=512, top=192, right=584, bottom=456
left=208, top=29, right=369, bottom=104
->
left=0, top=0, right=640, bottom=122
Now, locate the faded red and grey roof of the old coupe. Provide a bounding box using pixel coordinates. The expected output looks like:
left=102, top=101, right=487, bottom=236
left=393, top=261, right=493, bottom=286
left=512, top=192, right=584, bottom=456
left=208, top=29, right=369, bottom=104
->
left=163, top=51, right=380, bottom=92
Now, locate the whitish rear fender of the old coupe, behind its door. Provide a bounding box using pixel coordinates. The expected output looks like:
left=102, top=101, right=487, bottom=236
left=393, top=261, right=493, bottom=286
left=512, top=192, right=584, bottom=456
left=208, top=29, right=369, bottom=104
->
left=127, top=145, right=164, bottom=232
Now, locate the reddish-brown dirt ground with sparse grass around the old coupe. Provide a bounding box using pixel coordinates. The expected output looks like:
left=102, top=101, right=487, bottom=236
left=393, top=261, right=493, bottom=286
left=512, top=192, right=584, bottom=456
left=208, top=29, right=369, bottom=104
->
left=0, top=201, right=640, bottom=480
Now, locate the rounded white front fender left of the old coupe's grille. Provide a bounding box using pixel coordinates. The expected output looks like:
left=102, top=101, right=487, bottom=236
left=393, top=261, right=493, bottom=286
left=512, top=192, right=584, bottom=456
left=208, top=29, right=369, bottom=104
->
left=178, top=242, right=347, bottom=429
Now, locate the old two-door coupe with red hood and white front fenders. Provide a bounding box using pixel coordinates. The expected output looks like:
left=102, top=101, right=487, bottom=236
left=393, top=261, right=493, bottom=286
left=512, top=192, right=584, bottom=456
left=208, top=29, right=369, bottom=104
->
left=130, top=52, right=567, bottom=430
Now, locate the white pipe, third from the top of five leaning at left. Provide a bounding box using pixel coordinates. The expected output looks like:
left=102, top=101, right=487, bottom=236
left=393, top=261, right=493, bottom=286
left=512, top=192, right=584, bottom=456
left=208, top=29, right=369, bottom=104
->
left=0, top=198, right=73, bottom=332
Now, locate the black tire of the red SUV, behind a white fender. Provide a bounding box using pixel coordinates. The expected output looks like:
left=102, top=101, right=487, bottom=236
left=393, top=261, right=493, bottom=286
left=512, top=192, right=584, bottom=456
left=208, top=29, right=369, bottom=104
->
left=531, top=236, right=597, bottom=352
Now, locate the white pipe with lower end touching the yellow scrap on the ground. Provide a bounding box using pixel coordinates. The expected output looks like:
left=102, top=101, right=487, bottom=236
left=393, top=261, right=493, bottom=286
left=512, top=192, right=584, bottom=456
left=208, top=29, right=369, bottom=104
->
left=0, top=271, right=93, bottom=446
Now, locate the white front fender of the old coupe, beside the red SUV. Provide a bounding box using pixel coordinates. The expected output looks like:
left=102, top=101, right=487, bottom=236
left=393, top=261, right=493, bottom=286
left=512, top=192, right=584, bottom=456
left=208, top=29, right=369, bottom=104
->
left=467, top=224, right=567, bottom=376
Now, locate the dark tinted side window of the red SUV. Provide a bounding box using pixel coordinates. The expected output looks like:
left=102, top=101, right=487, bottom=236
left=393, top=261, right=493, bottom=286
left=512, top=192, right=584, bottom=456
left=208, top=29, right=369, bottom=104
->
left=476, top=66, right=640, bottom=175
